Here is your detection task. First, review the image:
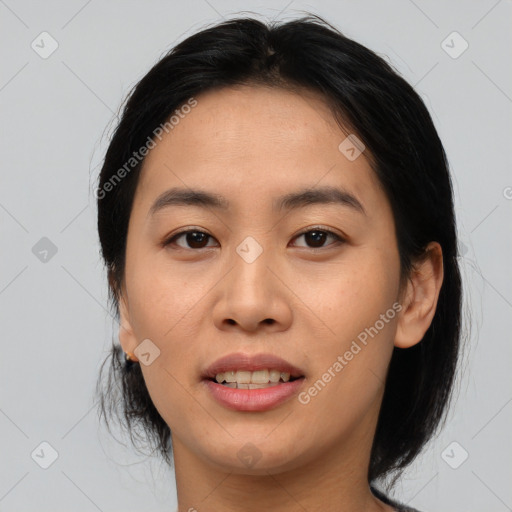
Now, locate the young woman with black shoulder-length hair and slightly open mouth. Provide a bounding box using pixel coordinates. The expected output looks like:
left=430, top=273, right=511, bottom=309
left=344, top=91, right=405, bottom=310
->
left=96, top=16, right=461, bottom=512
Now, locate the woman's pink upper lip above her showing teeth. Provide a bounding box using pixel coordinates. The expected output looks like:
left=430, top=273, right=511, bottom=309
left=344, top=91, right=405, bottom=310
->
left=203, top=352, right=304, bottom=379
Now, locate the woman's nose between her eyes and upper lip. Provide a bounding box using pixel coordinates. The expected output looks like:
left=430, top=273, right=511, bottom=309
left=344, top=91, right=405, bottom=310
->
left=213, top=238, right=293, bottom=333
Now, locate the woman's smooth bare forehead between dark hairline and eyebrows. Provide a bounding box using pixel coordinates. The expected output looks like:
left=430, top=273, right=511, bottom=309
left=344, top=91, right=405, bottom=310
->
left=134, top=86, right=379, bottom=212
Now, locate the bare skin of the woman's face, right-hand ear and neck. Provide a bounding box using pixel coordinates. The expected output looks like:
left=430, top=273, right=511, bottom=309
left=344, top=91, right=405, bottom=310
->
left=119, top=86, right=443, bottom=512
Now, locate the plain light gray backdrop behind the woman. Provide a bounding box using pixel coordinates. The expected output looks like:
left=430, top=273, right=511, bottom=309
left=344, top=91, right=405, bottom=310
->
left=0, top=0, right=512, bottom=512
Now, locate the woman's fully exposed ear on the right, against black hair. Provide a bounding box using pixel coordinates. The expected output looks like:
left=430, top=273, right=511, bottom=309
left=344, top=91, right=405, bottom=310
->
left=395, top=242, right=444, bottom=348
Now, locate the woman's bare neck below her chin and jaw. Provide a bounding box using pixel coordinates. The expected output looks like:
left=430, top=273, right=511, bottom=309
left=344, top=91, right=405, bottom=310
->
left=173, top=406, right=393, bottom=512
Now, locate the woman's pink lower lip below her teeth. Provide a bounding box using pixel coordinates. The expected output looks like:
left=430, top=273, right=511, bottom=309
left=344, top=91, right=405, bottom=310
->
left=203, top=377, right=304, bottom=411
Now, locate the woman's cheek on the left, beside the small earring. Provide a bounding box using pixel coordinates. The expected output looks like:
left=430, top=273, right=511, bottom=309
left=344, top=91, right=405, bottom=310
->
left=126, top=255, right=209, bottom=404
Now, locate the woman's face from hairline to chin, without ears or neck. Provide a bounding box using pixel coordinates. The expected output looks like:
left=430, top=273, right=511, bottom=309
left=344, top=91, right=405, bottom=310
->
left=120, top=86, right=400, bottom=474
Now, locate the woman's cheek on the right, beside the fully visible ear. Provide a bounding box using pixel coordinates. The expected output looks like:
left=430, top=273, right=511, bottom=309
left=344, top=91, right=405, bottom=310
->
left=301, top=250, right=400, bottom=416
